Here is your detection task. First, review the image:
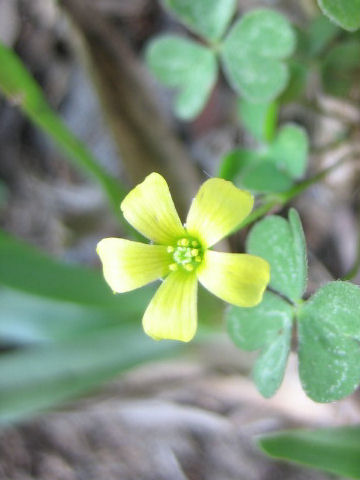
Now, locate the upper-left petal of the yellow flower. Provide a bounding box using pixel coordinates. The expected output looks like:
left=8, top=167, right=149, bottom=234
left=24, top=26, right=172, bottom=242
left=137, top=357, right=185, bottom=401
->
left=121, top=173, right=185, bottom=245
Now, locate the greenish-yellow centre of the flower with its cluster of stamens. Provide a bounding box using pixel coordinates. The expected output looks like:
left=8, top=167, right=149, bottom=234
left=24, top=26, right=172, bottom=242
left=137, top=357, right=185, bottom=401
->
left=167, top=237, right=203, bottom=272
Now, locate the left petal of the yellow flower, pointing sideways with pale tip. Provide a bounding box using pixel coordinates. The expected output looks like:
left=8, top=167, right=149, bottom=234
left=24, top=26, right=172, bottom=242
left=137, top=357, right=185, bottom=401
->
left=96, top=238, right=169, bottom=293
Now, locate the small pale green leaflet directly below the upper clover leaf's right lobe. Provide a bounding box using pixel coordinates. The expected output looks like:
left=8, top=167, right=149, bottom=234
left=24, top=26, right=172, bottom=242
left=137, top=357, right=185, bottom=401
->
left=238, top=99, right=278, bottom=142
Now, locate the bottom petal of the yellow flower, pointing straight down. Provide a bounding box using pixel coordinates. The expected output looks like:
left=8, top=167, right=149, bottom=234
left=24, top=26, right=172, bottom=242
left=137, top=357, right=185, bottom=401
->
left=143, top=271, right=197, bottom=342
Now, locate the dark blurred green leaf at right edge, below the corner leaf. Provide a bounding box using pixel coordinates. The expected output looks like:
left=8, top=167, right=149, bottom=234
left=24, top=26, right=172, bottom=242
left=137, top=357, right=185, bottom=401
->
left=321, top=41, right=360, bottom=97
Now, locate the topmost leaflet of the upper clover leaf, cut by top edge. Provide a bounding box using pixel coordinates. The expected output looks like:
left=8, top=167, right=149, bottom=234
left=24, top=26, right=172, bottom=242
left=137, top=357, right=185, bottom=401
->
left=163, top=0, right=236, bottom=42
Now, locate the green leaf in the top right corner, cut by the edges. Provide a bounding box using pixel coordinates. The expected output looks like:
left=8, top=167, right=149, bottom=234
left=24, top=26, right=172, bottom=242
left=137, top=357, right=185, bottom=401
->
left=318, top=0, right=360, bottom=32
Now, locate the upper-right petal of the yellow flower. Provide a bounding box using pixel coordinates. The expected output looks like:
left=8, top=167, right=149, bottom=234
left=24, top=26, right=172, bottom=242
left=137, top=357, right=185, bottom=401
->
left=186, top=178, right=254, bottom=247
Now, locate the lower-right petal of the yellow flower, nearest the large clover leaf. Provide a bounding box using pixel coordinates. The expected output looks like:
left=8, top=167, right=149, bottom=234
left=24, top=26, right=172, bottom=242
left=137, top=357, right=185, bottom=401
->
left=198, top=250, right=270, bottom=307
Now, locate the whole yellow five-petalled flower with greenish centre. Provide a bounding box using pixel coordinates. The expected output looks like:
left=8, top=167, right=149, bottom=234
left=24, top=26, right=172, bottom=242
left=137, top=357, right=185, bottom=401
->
left=97, top=173, right=270, bottom=342
